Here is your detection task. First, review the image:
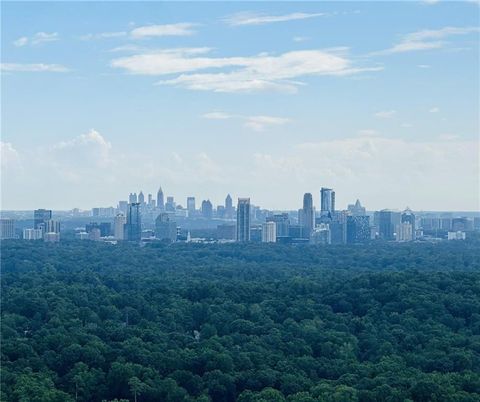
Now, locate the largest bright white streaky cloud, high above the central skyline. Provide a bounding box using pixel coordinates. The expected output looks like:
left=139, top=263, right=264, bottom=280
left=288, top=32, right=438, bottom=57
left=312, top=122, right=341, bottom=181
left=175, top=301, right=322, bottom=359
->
left=111, top=48, right=382, bottom=92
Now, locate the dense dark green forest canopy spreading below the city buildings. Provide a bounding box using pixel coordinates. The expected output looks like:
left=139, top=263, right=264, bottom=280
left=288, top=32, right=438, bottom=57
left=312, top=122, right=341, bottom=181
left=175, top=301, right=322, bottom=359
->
left=1, top=241, right=480, bottom=402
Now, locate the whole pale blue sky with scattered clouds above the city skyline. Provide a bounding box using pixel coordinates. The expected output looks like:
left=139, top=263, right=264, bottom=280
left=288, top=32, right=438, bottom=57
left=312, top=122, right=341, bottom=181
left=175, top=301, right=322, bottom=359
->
left=1, top=0, right=480, bottom=211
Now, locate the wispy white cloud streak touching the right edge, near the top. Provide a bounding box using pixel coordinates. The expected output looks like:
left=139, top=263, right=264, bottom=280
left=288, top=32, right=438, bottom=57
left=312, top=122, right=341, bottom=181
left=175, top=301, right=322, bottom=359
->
left=372, top=27, right=479, bottom=55
